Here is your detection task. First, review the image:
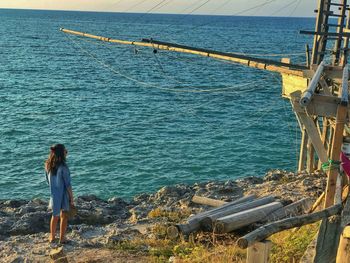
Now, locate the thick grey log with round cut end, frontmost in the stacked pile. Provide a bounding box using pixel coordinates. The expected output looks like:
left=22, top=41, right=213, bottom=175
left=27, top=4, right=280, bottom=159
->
left=214, top=202, right=283, bottom=233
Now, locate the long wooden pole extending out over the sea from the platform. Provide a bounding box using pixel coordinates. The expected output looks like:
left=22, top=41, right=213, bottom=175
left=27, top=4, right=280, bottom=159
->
left=60, top=28, right=307, bottom=76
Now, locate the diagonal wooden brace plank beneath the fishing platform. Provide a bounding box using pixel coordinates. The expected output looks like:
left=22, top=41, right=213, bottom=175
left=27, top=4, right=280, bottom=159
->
left=297, top=112, right=328, bottom=163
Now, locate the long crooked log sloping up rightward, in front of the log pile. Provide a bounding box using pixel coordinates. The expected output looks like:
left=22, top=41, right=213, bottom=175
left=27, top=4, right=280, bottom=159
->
left=237, top=204, right=342, bottom=248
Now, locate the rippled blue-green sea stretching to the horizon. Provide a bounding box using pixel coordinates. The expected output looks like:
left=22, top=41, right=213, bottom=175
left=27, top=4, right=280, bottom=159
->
left=0, top=9, right=314, bottom=199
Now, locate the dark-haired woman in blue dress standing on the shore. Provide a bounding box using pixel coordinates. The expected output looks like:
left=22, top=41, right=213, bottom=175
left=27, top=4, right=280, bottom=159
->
left=45, top=144, right=74, bottom=244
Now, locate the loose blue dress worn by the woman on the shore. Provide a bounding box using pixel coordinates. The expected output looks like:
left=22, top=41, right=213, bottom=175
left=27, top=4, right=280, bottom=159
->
left=46, top=164, right=71, bottom=216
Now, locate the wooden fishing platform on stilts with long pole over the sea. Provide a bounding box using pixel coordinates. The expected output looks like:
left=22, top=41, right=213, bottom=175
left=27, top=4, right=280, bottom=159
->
left=61, top=0, right=350, bottom=263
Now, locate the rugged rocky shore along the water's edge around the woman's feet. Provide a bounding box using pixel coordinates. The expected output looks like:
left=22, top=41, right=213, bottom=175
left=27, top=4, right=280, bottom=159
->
left=0, top=170, right=326, bottom=262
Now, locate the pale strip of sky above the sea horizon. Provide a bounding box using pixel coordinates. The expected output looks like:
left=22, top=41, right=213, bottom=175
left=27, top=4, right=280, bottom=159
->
left=0, top=0, right=317, bottom=17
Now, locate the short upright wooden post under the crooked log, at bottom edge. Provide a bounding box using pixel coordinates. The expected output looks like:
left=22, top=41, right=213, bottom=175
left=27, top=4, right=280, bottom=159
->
left=246, top=240, right=272, bottom=263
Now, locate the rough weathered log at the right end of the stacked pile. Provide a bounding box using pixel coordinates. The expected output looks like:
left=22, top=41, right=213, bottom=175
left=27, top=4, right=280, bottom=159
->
left=264, top=197, right=312, bottom=222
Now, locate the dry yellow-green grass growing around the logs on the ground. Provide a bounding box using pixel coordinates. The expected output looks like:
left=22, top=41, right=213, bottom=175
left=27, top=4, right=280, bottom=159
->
left=111, top=209, right=319, bottom=263
